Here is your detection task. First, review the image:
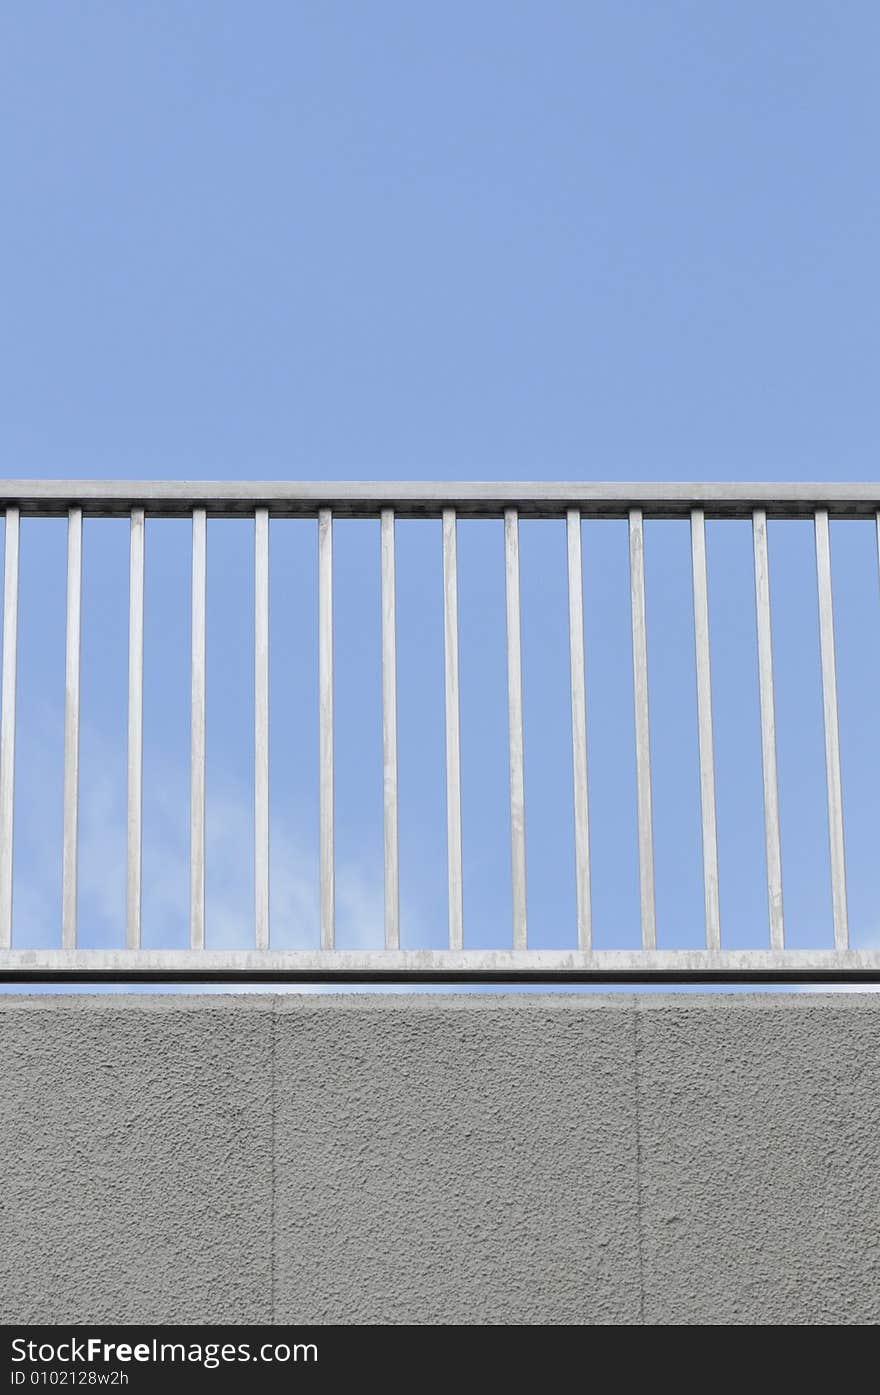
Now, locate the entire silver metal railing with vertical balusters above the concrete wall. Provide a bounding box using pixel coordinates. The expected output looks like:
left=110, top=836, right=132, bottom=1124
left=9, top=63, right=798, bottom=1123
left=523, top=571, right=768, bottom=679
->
left=0, top=481, right=880, bottom=981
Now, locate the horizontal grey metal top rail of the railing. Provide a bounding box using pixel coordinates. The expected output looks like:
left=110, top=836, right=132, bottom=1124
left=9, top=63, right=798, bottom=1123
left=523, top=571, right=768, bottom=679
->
left=0, top=480, right=880, bottom=518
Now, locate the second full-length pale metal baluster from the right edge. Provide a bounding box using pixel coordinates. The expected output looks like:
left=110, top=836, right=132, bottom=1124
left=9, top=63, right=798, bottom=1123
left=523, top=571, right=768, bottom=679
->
left=752, top=509, right=785, bottom=950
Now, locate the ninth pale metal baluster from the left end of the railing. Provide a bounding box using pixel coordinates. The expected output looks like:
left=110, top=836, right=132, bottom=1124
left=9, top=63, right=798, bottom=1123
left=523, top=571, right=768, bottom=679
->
left=505, top=509, right=529, bottom=950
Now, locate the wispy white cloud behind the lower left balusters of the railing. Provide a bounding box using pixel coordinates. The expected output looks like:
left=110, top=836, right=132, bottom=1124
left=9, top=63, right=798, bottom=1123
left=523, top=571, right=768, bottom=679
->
left=8, top=714, right=420, bottom=949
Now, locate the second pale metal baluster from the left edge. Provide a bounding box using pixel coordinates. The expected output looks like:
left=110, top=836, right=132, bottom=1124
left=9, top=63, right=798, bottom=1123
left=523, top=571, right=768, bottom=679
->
left=61, top=508, right=82, bottom=950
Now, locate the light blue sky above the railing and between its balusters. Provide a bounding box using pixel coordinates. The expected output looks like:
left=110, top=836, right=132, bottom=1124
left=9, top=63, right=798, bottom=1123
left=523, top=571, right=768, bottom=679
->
left=0, top=0, right=880, bottom=947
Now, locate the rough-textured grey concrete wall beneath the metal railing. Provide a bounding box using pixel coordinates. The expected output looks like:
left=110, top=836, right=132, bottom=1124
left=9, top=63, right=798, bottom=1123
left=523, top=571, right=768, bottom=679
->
left=0, top=993, right=880, bottom=1322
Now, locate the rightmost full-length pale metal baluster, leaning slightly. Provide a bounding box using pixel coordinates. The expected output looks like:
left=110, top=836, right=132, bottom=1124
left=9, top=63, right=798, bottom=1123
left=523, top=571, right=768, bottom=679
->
left=816, top=509, right=849, bottom=950
